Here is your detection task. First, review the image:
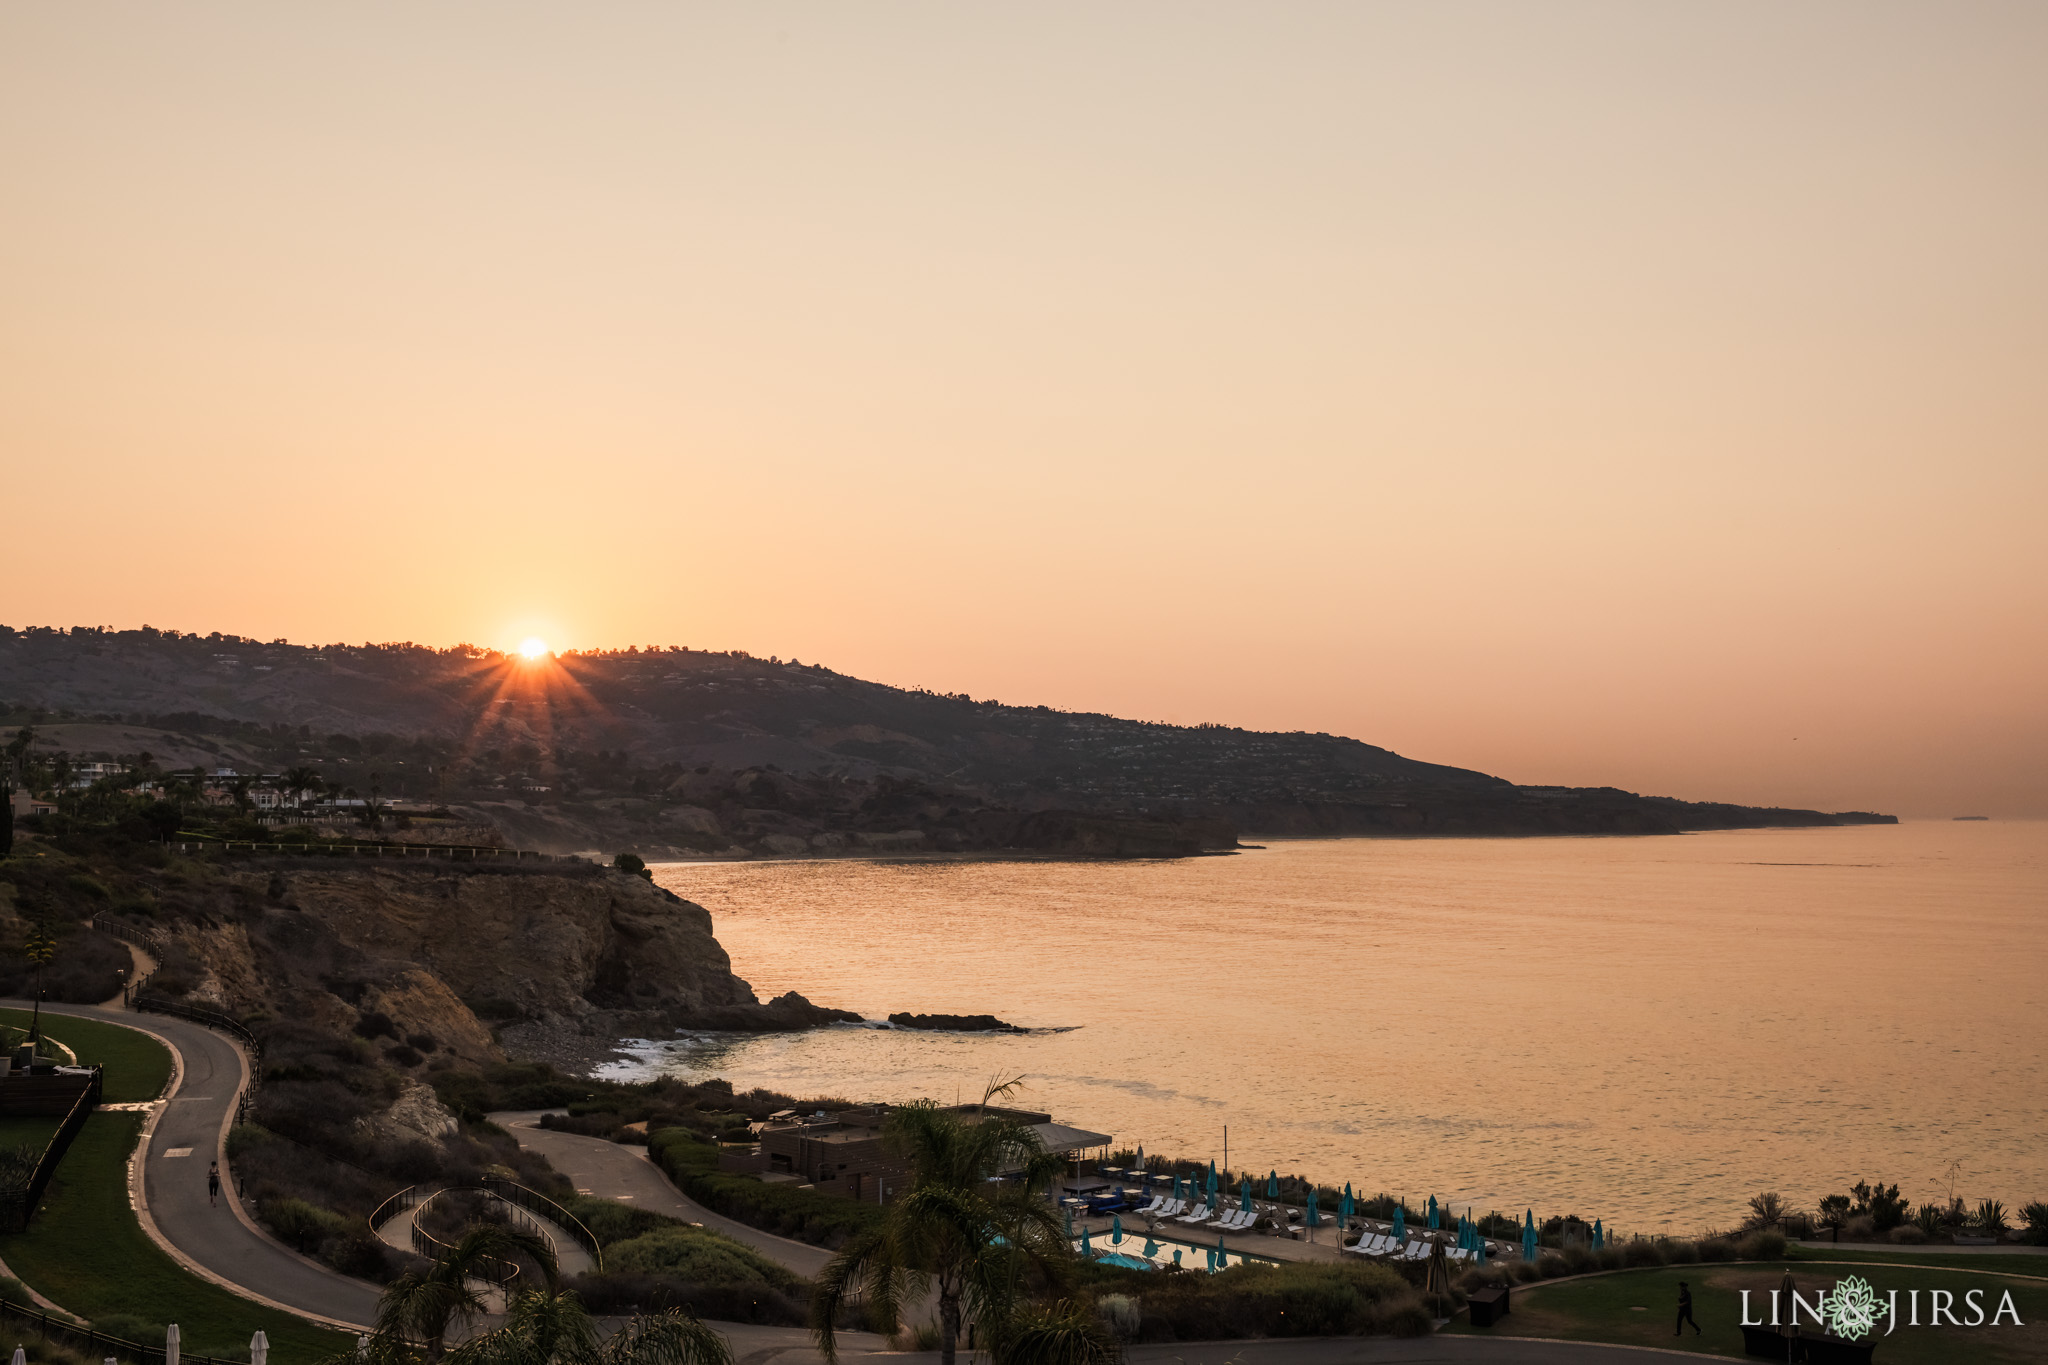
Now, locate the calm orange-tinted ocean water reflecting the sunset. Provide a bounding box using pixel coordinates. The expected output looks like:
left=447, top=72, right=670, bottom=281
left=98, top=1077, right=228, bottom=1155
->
left=630, top=823, right=2048, bottom=1232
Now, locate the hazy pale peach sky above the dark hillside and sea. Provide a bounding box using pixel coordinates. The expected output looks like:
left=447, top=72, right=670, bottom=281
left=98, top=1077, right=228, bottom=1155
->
left=0, top=0, right=2048, bottom=814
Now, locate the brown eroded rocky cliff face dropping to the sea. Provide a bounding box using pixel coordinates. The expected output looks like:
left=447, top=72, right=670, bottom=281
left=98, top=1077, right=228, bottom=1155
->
left=149, top=860, right=852, bottom=1062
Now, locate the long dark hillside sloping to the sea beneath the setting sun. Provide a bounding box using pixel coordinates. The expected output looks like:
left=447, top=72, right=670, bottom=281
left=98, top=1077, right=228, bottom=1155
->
left=0, top=628, right=1884, bottom=853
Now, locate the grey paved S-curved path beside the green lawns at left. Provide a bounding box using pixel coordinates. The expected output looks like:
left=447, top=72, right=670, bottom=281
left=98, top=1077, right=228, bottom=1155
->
left=8, top=1001, right=377, bottom=1332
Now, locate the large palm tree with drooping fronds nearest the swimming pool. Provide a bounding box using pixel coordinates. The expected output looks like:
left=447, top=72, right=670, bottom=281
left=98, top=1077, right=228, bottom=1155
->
left=811, top=1081, right=1116, bottom=1365
